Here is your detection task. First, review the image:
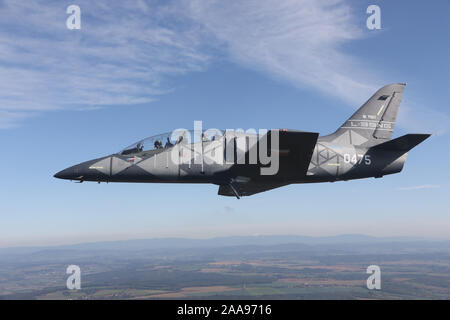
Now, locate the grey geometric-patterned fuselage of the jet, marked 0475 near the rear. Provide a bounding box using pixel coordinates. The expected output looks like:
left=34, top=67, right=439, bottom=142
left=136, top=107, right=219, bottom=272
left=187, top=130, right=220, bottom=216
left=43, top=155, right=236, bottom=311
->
left=55, top=132, right=406, bottom=184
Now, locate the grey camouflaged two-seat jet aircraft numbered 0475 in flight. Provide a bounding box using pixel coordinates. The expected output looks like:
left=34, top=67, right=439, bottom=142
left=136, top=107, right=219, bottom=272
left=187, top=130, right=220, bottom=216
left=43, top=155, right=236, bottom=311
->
left=54, top=83, right=430, bottom=199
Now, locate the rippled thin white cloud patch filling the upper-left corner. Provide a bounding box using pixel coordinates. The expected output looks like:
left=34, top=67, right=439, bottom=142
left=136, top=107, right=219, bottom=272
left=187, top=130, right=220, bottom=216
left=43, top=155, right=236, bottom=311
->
left=0, top=0, right=210, bottom=128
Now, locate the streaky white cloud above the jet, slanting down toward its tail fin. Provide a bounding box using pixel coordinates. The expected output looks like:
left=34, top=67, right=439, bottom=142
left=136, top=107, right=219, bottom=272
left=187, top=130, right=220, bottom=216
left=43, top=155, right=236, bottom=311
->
left=181, top=0, right=377, bottom=103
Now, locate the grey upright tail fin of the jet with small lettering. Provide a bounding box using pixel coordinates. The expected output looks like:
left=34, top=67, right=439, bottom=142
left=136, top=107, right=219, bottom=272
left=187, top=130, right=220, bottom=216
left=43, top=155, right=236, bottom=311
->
left=328, top=83, right=406, bottom=147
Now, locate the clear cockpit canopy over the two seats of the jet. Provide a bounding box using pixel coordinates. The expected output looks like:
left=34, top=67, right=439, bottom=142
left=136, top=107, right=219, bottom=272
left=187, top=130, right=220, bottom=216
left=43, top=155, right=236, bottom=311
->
left=119, top=129, right=222, bottom=155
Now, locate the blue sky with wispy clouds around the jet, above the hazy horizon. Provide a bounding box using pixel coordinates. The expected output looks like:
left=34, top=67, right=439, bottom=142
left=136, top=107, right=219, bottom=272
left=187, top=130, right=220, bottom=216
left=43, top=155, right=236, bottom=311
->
left=0, top=0, right=450, bottom=247
